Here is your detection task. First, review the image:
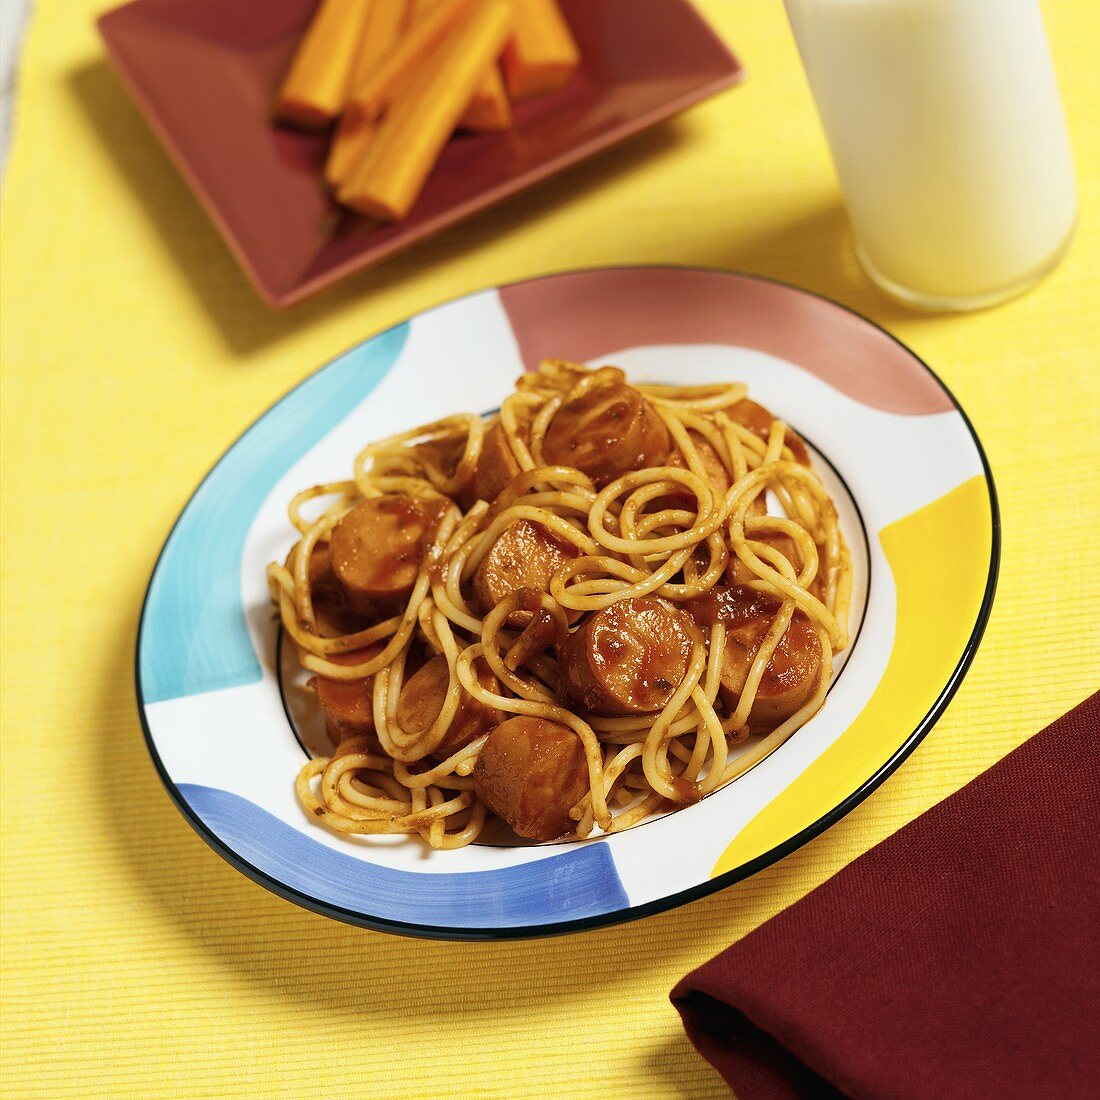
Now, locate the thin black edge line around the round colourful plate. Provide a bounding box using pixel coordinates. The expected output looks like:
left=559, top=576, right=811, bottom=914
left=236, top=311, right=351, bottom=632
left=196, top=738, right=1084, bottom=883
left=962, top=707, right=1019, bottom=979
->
left=134, top=264, right=1001, bottom=942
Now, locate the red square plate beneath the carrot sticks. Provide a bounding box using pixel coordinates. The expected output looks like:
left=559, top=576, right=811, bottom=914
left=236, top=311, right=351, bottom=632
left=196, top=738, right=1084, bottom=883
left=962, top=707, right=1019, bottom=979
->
left=99, top=0, right=741, bottom=308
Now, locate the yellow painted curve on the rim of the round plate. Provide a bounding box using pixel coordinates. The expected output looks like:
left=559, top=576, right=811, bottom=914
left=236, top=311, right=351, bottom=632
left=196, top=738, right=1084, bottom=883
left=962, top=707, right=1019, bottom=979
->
left=711, top=477, right=992, bottom=878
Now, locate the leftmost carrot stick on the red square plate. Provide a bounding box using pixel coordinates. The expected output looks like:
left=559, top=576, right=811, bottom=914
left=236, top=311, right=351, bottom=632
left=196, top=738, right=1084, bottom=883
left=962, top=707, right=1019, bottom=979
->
left=275, top=0, right=371, bottom=130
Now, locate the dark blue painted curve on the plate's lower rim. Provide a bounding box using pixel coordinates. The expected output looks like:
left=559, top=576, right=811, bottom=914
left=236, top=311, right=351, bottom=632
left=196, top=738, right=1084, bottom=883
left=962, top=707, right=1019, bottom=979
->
left=179, top=783, right=629, bottom=928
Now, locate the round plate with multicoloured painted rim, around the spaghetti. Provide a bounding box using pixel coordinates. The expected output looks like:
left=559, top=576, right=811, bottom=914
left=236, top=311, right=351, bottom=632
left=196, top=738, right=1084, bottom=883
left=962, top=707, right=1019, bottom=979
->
left=138, top=267, right=999, bottom=938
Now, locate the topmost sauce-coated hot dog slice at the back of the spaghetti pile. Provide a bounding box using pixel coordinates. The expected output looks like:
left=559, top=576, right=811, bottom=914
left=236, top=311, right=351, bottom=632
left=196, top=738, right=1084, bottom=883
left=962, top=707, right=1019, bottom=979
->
left=542, top=382, right=671, bottom=486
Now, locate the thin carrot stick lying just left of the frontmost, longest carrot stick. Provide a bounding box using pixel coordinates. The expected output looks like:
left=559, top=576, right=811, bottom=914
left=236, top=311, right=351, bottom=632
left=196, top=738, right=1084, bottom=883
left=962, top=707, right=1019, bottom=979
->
left=325, top=0, right=484, bottom=188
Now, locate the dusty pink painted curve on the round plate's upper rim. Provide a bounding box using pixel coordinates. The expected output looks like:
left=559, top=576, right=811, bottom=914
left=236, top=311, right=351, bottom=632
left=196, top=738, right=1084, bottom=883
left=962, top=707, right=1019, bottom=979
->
left=499, top=267, right=955, bottom=416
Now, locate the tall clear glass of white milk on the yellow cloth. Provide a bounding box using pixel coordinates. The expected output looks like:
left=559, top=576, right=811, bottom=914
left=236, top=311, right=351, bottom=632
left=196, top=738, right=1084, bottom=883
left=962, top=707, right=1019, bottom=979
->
left=785, top=0, right=1077, bottom=309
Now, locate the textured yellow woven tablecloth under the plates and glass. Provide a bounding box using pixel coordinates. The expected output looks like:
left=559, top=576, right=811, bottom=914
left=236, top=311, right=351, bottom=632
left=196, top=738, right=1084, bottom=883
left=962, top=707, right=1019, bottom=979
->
left=0, top=0, right=1100, bottom=1100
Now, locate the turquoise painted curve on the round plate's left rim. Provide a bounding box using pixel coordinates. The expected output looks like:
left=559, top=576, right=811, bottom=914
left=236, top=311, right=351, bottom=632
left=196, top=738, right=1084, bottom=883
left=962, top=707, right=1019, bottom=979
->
left=141, top=321, right=409, bottom=704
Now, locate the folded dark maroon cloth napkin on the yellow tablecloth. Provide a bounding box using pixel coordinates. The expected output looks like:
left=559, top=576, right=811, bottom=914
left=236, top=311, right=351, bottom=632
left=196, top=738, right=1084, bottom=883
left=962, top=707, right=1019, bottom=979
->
left=672, top=694, right=1100, bottom=1100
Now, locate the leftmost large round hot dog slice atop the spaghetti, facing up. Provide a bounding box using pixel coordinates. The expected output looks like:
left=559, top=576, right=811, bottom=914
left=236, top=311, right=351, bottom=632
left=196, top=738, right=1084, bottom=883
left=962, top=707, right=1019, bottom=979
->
left=331, top=493, right=446, bottom=616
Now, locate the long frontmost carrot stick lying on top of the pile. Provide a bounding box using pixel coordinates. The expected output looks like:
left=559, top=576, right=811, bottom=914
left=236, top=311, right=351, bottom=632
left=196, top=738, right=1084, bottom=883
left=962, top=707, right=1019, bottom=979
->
left=338, top=0, right=512, bottom=221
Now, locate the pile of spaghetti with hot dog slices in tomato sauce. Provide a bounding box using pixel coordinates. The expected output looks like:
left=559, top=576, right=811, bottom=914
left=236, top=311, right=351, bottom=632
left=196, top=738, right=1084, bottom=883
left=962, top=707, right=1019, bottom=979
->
left=268, top=361, right=851, bottom=848
